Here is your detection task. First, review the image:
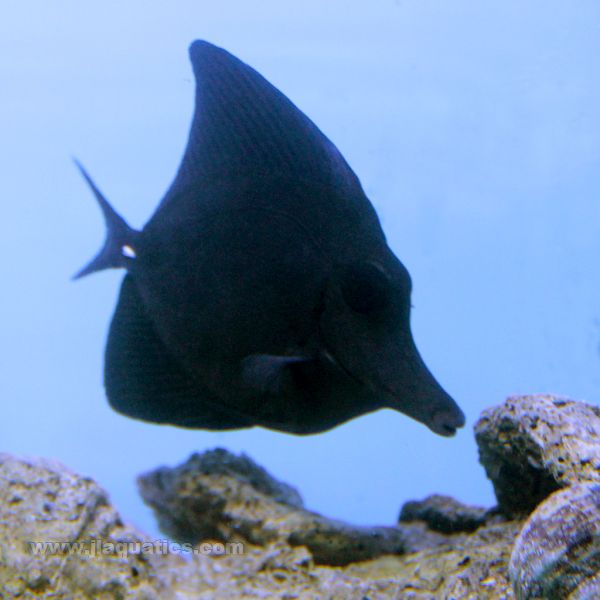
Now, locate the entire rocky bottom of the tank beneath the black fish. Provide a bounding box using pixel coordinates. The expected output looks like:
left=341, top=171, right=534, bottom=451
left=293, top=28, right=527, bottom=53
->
left=0, top=395, right=600, bottom=600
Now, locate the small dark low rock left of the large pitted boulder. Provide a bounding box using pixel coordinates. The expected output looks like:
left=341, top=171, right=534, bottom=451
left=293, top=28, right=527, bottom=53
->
left=398, top=494, right=488, bottom=533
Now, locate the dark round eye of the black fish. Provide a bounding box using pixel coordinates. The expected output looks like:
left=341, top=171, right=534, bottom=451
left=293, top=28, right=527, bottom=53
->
left=341, top=262, right=391, bottom=315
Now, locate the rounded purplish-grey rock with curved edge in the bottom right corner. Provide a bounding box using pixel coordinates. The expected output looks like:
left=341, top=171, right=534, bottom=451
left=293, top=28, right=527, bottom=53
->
left=509, top=483, right=600, bottom=600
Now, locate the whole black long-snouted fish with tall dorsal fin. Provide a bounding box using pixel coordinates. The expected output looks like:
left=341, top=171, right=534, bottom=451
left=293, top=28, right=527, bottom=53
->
left=77, top=41, right=464, bottom=435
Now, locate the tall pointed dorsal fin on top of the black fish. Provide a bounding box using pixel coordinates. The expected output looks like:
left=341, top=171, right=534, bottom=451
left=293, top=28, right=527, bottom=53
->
left=162, top=41, right=361, bottom=198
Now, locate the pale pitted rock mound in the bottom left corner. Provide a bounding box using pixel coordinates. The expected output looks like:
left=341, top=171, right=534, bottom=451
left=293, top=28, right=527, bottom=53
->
left=0, top=454, right=201, bottom=600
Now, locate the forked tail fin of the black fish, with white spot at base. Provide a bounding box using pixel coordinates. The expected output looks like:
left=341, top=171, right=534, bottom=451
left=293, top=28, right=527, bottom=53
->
left=73, top=160, right=139, bottom=279
